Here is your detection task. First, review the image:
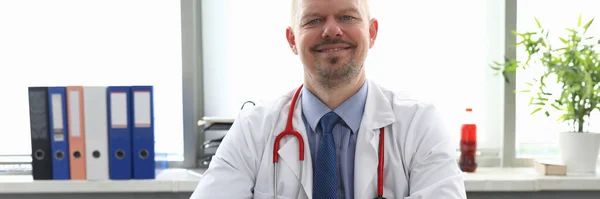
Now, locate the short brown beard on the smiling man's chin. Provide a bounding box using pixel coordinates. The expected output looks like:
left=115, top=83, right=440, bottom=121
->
left=316, top=55, right=362, bottom=89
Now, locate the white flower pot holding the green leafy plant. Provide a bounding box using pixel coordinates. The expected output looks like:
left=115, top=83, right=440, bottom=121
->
left=558, top=132, right=600, bottom=175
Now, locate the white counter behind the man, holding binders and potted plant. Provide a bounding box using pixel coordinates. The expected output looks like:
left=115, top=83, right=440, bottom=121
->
left=0, top=168, right=600, bottom=199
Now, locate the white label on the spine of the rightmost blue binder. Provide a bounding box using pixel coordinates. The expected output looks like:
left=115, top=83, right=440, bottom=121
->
left=133, top=91, right=152, bottom=127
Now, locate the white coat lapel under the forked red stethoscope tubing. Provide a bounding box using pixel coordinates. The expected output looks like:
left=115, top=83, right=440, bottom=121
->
left=275, top=93, right=313, bottom=198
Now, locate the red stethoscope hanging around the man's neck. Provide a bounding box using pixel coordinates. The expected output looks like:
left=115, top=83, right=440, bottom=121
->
left=273, top=85, right=385, bottom=199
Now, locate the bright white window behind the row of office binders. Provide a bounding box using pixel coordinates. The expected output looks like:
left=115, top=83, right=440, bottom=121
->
left=0, top=0, right=183, bottom=158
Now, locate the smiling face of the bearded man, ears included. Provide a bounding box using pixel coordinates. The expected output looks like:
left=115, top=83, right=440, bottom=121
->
left=287, top=0, right=377, bottom=84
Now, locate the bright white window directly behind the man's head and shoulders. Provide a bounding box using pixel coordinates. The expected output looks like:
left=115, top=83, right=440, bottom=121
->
left=202, top=0, right=504, bottom=153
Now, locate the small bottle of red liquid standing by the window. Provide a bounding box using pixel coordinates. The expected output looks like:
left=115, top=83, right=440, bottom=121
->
left=459, top=108, right=477, bottom=172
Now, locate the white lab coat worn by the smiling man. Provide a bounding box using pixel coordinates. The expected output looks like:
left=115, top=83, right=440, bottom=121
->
left=191, top=80, right=466, bottom=199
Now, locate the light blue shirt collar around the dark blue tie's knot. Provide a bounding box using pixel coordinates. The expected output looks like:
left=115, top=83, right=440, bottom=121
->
left=300, top=81, right=368, bottom=133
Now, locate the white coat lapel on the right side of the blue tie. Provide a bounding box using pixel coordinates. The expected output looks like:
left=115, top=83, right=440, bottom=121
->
left=354, top=81, right=396, bottom=198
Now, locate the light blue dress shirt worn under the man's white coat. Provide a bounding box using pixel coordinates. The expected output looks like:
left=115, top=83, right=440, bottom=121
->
left=300, top=81, right=368, bottom=199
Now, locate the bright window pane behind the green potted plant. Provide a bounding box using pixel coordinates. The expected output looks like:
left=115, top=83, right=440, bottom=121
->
left=516, top=0, right=600, bottom=158
